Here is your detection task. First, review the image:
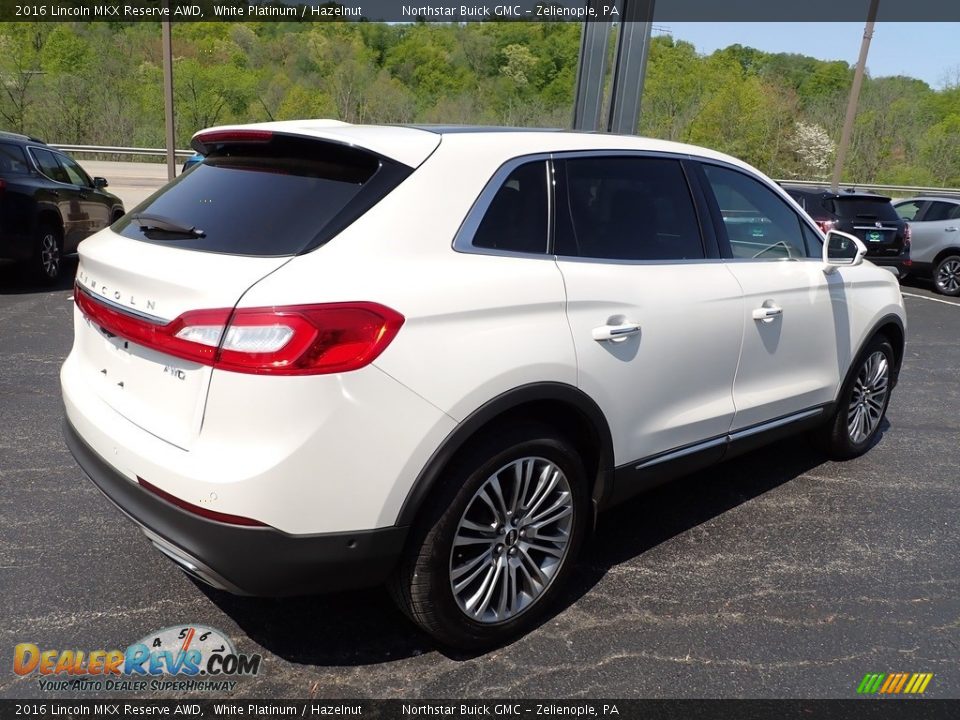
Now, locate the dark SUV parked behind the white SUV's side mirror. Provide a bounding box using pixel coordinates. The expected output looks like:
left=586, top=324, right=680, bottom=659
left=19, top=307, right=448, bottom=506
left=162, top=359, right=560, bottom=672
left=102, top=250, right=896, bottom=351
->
left=783, top=184, right=911, bottom=280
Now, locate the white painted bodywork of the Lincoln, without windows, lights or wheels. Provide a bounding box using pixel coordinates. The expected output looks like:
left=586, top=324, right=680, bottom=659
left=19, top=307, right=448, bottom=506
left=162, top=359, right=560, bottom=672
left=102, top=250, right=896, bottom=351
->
left=61, top=121, right=904, bottom=535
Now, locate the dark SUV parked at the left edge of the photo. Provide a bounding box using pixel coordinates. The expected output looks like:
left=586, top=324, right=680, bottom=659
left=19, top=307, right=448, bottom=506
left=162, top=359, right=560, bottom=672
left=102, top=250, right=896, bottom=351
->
left=0, top=132, right=124, bottom=283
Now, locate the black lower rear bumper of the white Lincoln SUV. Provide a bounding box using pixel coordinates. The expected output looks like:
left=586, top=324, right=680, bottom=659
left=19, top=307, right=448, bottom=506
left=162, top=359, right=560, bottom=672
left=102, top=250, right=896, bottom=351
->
left=64, top=421, right=407, bottom=596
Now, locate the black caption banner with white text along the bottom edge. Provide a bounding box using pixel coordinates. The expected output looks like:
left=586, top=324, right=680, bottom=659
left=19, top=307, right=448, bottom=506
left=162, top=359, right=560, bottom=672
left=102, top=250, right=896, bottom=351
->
left=0, top=698, right=960, bottom=720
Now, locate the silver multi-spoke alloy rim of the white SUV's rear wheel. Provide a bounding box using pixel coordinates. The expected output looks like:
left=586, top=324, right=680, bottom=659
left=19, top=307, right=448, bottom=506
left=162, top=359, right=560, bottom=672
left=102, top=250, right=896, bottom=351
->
left=450, top=457, right=574, bottom=624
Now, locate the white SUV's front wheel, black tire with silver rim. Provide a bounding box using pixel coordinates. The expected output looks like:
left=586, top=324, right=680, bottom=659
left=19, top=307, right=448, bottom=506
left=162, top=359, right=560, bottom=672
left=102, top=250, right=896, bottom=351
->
left=813, top=335, right=894, bottom=460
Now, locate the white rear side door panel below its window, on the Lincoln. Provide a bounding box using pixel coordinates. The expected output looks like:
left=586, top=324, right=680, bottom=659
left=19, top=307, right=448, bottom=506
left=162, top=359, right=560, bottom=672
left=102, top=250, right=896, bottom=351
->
left=558, top=258, right=743, bottom=465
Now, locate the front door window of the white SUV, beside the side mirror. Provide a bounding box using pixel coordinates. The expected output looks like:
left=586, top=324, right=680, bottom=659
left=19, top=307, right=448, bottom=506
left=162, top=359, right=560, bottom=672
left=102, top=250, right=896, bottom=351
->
left=703, top=164, right=808, bottom=260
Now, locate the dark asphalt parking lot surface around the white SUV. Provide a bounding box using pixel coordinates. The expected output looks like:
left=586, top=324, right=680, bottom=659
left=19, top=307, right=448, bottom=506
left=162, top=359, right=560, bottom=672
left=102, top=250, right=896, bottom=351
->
left=0, top=267, right=960, bottom=698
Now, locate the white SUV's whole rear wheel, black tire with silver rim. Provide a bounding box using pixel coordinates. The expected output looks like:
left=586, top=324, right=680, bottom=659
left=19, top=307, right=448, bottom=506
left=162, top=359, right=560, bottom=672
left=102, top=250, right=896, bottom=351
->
left=391, top=422, right=590, bottom=650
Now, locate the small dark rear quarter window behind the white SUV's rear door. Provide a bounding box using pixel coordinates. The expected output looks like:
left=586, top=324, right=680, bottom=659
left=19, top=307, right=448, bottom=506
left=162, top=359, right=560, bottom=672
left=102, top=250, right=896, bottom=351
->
left=473, top=161, right=547, bottom=254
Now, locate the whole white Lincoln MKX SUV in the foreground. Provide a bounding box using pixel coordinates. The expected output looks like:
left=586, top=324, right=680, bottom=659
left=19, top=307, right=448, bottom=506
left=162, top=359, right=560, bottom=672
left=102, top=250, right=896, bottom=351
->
left=61, top=121, right=905, bottom=647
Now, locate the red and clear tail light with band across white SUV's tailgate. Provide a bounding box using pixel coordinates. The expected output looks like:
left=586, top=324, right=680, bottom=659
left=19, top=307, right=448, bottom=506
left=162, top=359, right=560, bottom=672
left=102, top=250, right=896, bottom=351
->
left=74, top=286, right=404, bottom=375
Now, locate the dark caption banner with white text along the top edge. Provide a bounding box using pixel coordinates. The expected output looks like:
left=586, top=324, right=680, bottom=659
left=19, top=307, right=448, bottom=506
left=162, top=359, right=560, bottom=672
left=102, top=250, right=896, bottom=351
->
left=0, top=0, right=960, bottom=22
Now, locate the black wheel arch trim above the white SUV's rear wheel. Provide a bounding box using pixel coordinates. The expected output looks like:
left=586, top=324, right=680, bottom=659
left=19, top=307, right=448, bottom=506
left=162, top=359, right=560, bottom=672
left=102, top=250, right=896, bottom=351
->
left=396, top=382, right=614, bottom=525
